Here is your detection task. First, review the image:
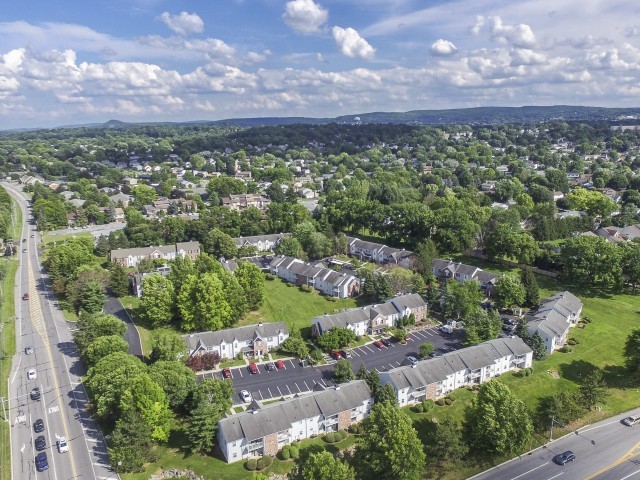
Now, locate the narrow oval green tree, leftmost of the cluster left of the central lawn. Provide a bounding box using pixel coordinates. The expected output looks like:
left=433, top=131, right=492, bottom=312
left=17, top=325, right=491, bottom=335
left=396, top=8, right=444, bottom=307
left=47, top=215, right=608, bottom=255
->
left=138, top=273, right=176, bottom=328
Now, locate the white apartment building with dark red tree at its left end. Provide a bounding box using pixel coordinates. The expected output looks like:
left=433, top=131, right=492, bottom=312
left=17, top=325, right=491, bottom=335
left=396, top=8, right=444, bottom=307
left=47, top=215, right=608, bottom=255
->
left=182, top=322, right=289, bottom=358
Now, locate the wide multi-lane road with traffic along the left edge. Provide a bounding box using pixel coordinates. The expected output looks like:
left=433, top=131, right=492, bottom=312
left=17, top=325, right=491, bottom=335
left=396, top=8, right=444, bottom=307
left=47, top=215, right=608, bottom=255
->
left=3, top=183, right=118, bottom=480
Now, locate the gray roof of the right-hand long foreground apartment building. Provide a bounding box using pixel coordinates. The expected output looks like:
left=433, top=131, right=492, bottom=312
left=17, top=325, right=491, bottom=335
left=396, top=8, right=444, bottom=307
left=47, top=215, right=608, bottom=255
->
left=383, top=337, right=532, bottom=389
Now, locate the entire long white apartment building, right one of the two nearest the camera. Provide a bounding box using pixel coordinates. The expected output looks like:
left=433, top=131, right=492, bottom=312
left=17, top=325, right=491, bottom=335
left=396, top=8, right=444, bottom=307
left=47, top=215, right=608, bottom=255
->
left=380, top=337, right=533, bottom=407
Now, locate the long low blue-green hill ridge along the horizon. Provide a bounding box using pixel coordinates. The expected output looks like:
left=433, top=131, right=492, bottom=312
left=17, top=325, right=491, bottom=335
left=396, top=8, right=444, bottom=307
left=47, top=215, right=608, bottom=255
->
left=41, top=105, right=640, bottom=129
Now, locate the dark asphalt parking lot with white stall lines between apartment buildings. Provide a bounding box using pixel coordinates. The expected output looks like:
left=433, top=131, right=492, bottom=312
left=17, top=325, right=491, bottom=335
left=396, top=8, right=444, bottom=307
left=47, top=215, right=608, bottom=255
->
left=201, top=328, right=462, bottom=404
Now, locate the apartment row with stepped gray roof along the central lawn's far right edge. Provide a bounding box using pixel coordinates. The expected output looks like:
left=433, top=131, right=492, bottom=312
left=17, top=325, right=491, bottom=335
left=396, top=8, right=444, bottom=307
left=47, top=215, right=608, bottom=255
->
left=269, top=255, right=360, bottom=298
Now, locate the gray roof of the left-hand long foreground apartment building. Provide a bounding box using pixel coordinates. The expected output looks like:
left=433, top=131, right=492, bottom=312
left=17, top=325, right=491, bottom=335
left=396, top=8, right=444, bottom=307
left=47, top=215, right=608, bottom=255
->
left=218, top=380, right=371, bottom=442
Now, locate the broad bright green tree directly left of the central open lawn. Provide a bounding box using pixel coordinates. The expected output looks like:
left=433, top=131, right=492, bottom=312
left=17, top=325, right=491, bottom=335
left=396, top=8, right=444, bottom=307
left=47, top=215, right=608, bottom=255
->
left=177, top=273, right=233, bottom=332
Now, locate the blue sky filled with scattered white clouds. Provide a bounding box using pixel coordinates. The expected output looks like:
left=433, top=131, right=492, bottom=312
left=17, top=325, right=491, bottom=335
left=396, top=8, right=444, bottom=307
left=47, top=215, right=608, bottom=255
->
left=0, top=0, right=640, bottom=129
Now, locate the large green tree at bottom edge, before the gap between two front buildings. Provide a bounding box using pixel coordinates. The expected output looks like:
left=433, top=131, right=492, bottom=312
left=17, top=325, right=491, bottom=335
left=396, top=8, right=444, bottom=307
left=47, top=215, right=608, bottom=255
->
left=356, top=402, right=426, bottom=480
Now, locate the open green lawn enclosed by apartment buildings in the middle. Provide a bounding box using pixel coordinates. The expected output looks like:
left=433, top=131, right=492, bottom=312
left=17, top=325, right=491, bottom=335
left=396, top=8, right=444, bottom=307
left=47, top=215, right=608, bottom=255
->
left=238, top=279, right=357, bottom=337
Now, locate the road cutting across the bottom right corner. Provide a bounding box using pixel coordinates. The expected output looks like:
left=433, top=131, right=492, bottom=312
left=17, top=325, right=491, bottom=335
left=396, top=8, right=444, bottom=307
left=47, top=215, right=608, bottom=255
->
left=472, top=411, right=640, bottom=480
